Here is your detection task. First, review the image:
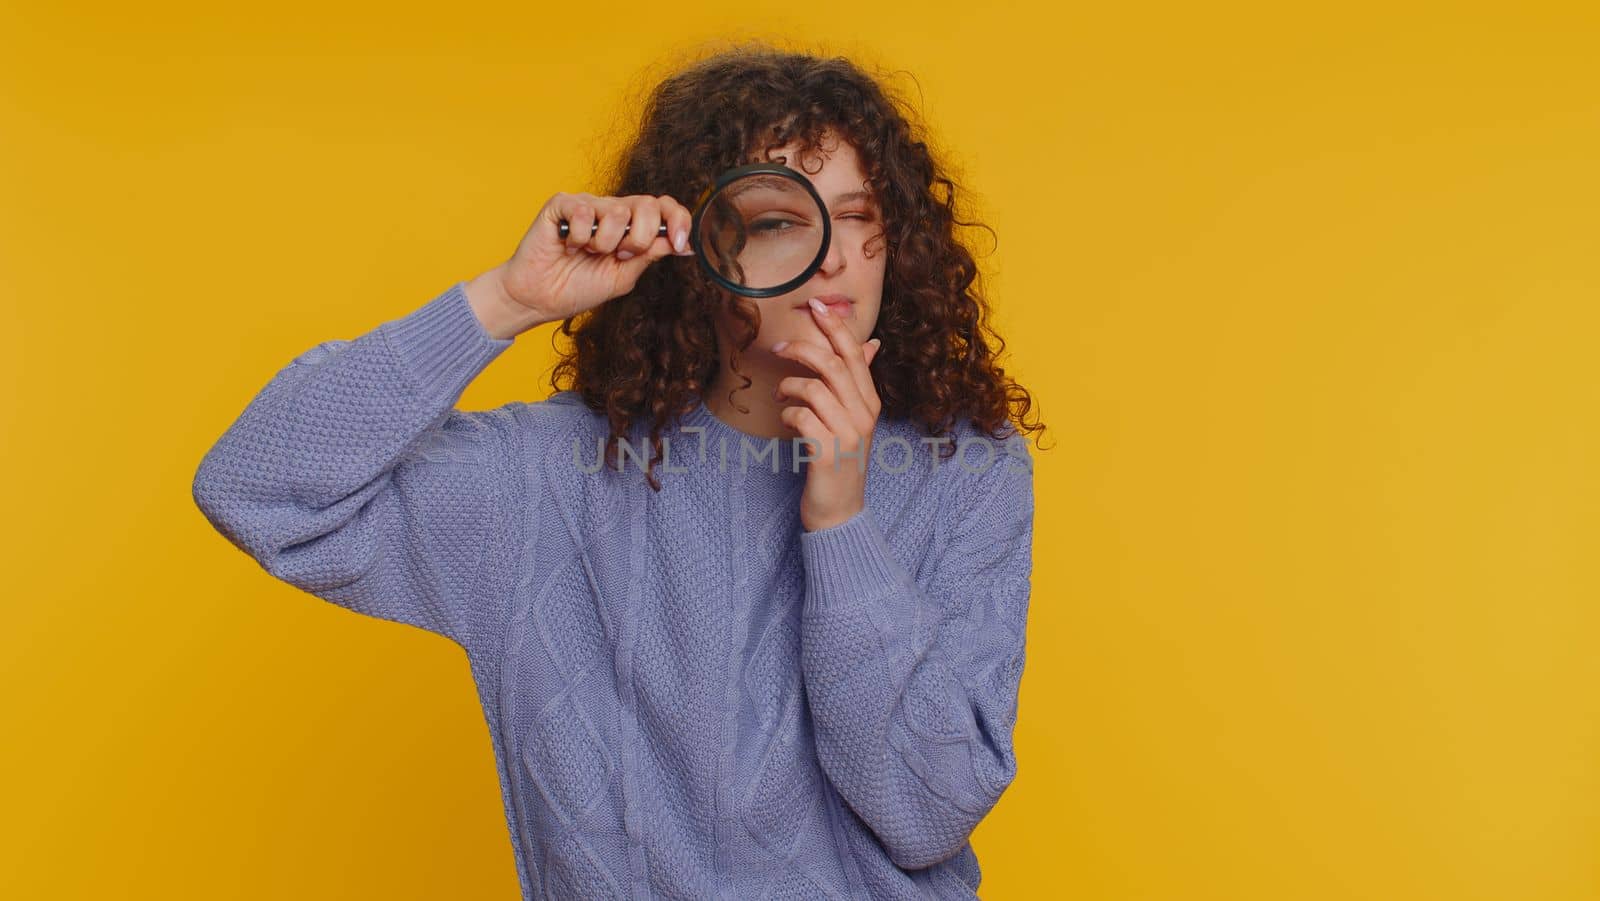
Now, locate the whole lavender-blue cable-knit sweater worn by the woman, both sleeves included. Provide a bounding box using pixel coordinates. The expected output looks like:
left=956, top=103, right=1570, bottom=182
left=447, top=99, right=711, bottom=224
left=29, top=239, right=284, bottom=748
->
left=194, top=282, right=1034, bottom=901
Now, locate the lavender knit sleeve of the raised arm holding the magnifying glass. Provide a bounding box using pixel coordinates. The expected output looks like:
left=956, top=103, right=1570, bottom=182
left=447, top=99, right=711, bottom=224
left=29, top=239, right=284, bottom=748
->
left=192, top=282, right=514, bottom=650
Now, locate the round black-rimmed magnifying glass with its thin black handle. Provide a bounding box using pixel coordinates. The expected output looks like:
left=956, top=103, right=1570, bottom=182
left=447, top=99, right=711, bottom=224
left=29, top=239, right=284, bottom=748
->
left=558, top=163, right=834, bottom=298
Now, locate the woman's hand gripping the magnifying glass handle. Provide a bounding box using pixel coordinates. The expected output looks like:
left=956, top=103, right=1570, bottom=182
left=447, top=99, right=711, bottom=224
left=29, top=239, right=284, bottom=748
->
left=485, top=194, right=694, bottom=334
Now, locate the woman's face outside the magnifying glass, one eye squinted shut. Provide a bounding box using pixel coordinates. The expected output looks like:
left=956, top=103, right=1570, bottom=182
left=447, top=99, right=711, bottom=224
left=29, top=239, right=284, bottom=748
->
left=717, top=134, right=888, bottom=369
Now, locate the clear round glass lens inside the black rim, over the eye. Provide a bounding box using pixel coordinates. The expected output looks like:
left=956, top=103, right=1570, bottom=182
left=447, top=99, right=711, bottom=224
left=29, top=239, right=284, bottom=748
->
left=699, top=173, right=827, bottom=290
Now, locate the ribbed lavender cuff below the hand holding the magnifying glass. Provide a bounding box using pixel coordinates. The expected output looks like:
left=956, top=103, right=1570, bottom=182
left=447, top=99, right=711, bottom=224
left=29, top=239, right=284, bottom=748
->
left=379, top=282, right=514, bottom=398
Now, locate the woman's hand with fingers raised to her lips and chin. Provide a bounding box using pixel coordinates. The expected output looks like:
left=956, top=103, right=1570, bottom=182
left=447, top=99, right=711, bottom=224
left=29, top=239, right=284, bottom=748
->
left=773, top=302, right=882, bottom=531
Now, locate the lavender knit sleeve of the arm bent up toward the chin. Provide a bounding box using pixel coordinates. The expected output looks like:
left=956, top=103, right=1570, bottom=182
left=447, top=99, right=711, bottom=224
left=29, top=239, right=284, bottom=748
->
left=800, top=434, right=1034, bottom=869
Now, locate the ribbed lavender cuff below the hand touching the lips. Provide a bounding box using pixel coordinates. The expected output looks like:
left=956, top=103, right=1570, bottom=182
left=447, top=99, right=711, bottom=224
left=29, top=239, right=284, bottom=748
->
left=800, top=507, right=910, bottom=611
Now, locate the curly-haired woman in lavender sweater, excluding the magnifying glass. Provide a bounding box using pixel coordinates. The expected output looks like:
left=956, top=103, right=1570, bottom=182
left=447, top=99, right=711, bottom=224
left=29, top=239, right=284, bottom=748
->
left=194, top=46, right=1042, bottom=899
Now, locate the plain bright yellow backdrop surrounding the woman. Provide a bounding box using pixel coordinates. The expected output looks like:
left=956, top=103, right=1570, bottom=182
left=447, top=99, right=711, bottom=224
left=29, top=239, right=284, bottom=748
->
left=0, top=2, right=1600, bottom=901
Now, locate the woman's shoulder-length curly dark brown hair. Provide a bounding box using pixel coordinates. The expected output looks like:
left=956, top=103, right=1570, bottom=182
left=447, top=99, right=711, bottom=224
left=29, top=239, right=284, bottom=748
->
left=550, top=43, right=1045, bottom=491
